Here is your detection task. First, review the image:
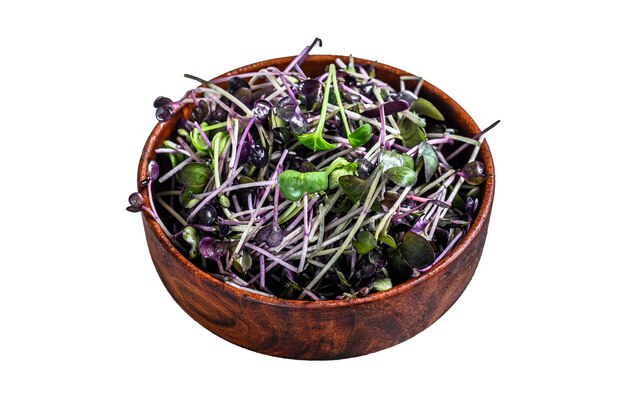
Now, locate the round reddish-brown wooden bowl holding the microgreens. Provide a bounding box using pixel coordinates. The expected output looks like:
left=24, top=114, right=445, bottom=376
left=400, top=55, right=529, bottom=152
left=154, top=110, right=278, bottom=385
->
left=138, top=55, right=495, bottom=359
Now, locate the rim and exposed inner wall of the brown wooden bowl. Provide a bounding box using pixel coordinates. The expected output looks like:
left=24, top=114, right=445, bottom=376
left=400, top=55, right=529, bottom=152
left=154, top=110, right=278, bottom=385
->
left=138, top=55, right=495, bottom=308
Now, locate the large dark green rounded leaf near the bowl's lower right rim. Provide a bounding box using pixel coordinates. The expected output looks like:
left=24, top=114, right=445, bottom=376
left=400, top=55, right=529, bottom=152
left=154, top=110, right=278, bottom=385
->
left=387, top=231, right=435, bottom=281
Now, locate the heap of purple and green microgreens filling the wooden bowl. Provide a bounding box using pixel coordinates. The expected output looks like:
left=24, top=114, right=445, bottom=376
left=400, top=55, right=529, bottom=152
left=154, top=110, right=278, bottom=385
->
left=127, top=38, right=497, bottom=301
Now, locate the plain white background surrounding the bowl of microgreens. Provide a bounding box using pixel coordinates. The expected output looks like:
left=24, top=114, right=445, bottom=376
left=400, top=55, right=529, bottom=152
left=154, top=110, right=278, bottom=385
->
left=0, top=0, right=626, bottom=400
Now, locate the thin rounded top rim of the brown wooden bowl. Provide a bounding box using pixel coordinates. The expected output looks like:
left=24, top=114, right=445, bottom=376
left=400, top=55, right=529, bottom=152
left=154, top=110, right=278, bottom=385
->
left=137, top=54, right=495, bottom=309
